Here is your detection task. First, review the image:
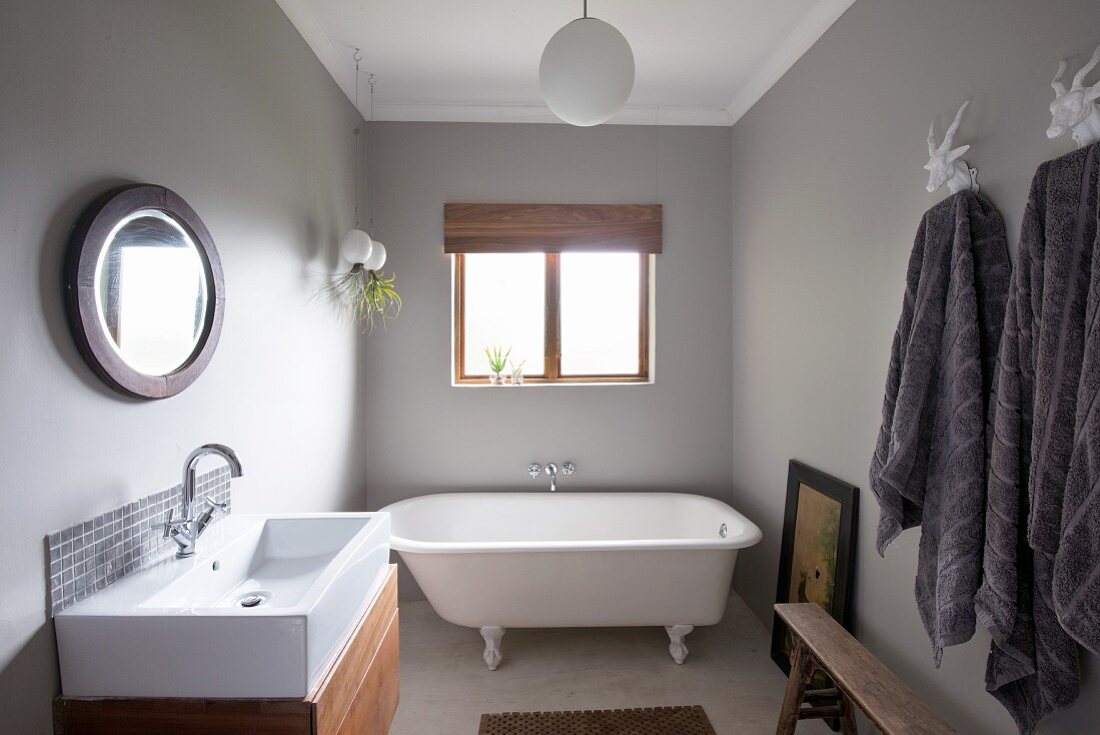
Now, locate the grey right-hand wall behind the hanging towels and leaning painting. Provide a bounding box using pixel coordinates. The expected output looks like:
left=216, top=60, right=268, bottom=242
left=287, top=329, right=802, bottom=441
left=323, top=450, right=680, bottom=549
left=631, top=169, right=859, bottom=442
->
left=732, top=0, right=1100, bottom=735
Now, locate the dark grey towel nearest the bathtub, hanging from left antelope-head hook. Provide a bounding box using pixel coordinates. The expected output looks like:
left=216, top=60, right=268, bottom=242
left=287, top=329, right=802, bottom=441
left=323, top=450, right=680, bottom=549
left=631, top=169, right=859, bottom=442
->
left=870, top=191, right=1011, bottom=666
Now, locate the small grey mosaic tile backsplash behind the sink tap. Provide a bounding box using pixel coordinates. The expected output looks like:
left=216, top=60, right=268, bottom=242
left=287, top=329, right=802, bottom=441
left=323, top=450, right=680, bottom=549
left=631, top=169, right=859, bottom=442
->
left=46, top=467, right=230, bottom=615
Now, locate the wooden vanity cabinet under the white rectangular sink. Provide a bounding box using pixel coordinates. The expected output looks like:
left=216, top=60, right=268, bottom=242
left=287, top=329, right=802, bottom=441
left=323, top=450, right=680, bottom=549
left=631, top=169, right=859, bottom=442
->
left=54, top=564, right=399, bottom=735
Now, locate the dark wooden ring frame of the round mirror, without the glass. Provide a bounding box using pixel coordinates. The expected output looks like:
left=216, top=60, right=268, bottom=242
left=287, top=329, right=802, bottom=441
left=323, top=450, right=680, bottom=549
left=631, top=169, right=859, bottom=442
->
left=64, top=184, right=226, bottom=398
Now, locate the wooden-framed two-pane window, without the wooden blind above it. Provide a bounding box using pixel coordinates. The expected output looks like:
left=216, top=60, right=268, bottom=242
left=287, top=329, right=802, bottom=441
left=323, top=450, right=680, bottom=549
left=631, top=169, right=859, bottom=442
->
left=454, top=252, right=650, bottom=383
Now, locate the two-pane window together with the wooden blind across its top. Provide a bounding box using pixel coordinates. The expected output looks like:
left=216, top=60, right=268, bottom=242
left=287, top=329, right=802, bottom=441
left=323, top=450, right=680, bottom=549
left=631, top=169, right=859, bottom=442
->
left=443, top=204, right=661, bottom=383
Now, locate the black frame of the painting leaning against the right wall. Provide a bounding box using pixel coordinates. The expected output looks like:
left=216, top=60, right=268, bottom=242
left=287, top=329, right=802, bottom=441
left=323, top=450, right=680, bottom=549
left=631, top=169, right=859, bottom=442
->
left=771, top=459, right=859, bottom=676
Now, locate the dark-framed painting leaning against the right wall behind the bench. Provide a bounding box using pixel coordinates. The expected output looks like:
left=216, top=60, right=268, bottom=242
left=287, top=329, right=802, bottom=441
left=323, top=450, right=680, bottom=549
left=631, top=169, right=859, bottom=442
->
left=771, top=460, right=859, bottom=673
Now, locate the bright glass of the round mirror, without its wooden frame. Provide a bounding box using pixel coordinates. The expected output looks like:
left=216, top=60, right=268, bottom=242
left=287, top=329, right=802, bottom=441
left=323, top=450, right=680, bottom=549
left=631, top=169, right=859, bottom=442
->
left=96, top=209, right=210, bottom=375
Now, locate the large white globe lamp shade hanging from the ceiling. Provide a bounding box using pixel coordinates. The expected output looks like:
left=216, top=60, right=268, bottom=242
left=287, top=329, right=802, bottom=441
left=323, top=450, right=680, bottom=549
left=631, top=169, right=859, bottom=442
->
left=539, top=18, right=634, bottom=127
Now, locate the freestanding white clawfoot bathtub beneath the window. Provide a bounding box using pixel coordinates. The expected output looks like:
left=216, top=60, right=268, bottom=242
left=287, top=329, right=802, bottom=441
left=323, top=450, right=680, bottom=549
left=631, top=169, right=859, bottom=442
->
left=382, top=492, right=761, bottom=670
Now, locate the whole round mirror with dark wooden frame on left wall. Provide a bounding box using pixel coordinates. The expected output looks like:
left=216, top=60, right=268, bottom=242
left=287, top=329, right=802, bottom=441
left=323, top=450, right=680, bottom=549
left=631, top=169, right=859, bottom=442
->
left=66, top=185, right=224, bottom=398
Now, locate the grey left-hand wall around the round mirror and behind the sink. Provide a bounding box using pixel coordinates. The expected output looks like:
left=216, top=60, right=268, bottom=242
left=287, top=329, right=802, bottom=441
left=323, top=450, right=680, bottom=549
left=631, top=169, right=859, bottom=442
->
left=0, top=0, right=365, bottom=734
